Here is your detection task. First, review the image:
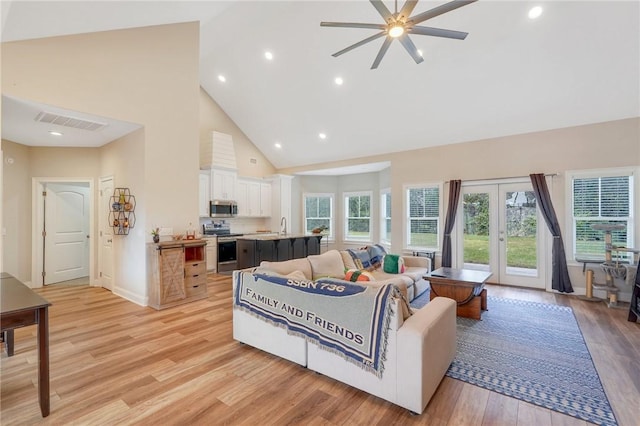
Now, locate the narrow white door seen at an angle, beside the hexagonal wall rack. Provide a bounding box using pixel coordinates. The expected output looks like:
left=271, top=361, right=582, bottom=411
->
left=98, top=177, right=113, bottom=290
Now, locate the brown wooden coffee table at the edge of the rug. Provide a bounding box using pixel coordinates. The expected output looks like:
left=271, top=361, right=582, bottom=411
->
left=424, top=268, right=492, bottom=320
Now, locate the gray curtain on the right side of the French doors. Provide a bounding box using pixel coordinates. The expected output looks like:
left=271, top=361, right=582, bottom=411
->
left=529, top=173, right=573, bottom=293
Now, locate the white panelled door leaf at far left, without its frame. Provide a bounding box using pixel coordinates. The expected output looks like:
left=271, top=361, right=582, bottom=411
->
left=44, top=183, right=90, bottom=285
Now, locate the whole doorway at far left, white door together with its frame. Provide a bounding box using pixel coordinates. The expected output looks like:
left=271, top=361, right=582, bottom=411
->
left=32, top=178, right=93, bottom=285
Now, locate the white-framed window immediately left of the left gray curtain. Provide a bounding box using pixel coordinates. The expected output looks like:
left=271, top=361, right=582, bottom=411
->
left=406, top=185, right=440, bottom=249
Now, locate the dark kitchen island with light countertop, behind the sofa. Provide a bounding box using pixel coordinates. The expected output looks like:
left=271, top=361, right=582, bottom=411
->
left=237, top=234, right=322, bottom=269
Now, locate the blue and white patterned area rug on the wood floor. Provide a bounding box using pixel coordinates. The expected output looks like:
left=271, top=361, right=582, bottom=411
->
left=447, top=296, right=617, bottom=425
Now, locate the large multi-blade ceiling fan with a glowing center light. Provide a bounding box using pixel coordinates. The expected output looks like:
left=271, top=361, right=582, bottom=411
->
left=320, top=0, right=477, bottom=69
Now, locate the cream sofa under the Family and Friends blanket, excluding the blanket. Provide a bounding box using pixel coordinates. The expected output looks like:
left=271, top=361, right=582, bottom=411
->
left=233, top=251, right=456, bottom=414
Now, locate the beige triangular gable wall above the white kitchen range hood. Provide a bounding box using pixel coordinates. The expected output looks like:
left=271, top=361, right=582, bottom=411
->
left=200, top=88, right=275, bottom=178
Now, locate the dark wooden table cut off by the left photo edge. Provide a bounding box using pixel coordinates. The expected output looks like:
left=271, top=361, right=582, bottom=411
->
left=0, top=272, right=51, bottom=417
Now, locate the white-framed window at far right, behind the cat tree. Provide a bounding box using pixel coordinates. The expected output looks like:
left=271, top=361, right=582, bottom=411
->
left=571, top=172, right=634, bottom=260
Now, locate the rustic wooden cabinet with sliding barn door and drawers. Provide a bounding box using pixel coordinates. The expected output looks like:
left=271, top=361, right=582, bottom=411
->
left=147, top=240, right=207, bottom=309
